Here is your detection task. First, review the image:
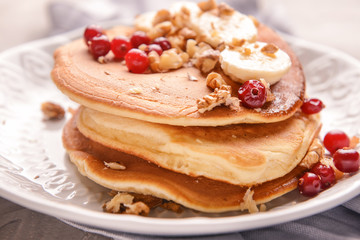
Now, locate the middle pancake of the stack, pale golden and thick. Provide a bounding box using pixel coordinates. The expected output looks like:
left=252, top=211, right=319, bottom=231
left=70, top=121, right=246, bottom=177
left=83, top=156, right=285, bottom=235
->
left=77, top=107, right=321, bottom=186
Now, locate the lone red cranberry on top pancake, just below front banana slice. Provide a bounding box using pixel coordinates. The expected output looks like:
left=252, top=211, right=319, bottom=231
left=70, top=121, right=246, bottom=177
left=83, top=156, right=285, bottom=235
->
left=238, top=80, right=266, bottom=108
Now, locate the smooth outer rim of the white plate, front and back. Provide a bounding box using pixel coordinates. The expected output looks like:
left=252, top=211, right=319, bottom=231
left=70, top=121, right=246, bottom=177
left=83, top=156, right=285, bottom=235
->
left=0, top=24, right=360, bottom=236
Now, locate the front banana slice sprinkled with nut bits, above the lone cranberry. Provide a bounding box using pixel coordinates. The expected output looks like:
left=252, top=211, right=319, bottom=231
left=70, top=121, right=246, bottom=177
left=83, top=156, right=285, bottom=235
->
left=220, top=42, right=291, bottom=84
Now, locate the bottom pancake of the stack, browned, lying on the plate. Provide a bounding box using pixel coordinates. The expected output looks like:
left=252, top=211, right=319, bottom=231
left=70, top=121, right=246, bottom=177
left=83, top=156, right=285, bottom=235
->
left=63, top=109, right=322, bottom=212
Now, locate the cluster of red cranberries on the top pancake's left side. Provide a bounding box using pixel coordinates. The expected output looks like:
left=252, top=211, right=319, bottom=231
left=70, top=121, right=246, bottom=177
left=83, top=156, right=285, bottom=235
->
left=84, top=25, right=171, bottom=73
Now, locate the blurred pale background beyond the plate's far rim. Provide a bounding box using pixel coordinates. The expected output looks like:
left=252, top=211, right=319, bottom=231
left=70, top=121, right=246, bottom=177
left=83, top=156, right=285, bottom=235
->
left=0, top=0, right=360, bottom=59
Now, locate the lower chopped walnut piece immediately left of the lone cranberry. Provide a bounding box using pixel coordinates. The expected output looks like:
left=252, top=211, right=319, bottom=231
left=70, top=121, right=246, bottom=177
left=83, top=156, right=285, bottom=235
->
left=196, top=85, right=231, bottom=113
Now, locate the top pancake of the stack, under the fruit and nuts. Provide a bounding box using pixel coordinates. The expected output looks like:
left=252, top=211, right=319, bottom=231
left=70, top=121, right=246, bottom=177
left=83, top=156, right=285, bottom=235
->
left=51, top=24, right=305, bottom=126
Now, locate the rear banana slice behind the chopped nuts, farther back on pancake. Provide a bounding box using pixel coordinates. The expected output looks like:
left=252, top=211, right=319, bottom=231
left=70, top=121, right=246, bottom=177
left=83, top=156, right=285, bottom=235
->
left=191, top=11, right=257, bottom=47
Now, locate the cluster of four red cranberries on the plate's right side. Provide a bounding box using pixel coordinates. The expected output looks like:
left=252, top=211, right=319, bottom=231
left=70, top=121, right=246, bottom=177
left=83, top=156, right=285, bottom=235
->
left=298, top=130, right=360, bottom=197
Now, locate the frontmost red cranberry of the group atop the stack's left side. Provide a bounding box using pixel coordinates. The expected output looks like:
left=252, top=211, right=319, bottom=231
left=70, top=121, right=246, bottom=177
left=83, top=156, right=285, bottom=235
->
left=125, top=48, right=149, bottom=73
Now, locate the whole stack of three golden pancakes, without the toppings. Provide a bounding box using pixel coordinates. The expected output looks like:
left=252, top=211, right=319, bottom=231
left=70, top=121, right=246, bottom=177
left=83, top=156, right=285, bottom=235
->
left=52, top=24, right=321, bottom=212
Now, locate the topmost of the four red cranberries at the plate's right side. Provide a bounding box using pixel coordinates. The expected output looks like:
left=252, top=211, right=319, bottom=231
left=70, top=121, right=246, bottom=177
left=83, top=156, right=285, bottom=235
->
left=324, top=130, right=350, bottom=154
